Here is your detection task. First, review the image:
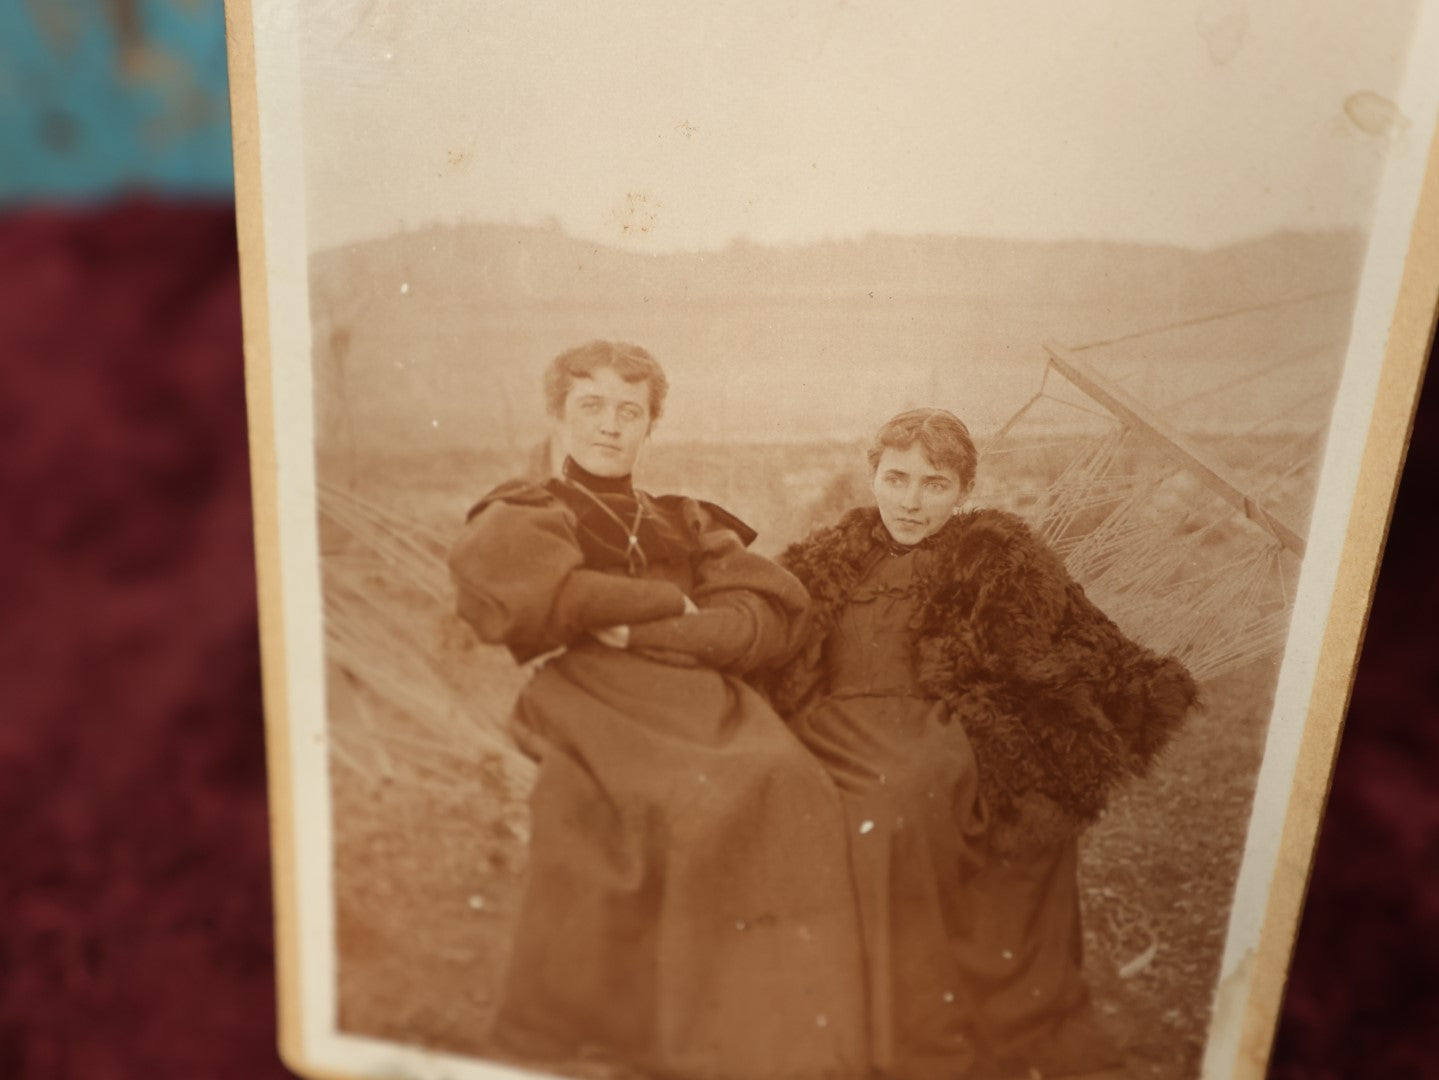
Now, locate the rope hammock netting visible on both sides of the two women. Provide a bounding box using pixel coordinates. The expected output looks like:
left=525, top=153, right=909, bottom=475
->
left=318, top=283, right=1343, bottom=788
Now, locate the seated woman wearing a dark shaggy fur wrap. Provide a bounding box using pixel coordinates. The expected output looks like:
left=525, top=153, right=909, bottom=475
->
left=767, top=408, right=1196, bottom=1077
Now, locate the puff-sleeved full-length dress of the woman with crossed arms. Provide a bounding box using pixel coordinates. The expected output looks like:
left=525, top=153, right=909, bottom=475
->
left=450, top=466, right=868, bottom=1080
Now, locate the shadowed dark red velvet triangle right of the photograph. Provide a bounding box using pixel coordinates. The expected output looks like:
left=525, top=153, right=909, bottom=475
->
left=1269, top=336, right=1439, bottom=1080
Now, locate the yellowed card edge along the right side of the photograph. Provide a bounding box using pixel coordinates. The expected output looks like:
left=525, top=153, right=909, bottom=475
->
left=1233, top=117, right=1439, bottom=1080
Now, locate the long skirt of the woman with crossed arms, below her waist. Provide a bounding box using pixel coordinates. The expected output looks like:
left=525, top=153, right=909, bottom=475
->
left=492, top=644, right=868, bottom=1080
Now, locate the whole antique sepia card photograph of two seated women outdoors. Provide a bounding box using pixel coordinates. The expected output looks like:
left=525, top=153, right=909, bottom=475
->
left=221, top=0, right=1439, bottom=1080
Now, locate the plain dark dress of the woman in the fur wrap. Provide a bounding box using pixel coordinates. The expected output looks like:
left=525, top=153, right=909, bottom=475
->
left=791, top=526, right=983, bottom=1080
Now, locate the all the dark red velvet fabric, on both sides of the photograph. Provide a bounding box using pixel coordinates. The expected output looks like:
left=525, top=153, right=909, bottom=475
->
left=0, top=203, right=1439, bottom=1080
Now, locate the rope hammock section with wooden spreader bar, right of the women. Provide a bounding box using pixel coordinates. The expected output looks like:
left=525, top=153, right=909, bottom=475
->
left=981, top=292, right=1343, bottom=680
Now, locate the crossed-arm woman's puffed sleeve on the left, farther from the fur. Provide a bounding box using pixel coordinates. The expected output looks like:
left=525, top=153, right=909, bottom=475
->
left=449, top=499, right=685, bottom=657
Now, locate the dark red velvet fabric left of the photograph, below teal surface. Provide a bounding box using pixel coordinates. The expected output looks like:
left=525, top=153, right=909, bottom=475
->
left=0, top=204, right=288, bottom=1080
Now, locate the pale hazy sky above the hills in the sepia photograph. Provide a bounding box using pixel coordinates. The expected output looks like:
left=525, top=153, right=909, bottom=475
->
left=302, top=0, right=1415, bottom=250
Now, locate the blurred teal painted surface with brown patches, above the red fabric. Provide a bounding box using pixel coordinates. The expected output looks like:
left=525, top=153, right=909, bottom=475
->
left=0, top=0, right=232, bottom=203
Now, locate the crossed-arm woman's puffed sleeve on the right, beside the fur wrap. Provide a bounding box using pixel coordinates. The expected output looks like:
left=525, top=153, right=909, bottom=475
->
left=629, top=503, right=809, bottom=673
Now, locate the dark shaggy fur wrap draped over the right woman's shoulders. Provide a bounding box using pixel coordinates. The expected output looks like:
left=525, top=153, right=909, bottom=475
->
left=763, top=508, right=1199, bottom=856
